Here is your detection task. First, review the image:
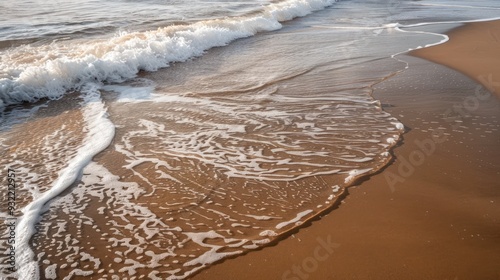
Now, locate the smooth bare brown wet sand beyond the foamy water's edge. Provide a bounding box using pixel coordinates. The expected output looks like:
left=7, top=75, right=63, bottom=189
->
left=193, top=21, right=500, bottom=280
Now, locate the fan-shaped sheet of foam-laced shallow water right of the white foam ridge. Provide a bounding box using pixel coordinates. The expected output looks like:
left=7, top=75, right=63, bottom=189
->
left=26, top=76, right=403, bottom=279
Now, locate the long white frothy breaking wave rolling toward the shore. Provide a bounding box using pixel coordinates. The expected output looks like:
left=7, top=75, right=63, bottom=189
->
left=0, top=0, right=336, bottom=112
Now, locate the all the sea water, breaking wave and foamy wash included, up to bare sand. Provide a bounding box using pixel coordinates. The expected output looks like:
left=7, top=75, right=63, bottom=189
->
left=0, top=0, right=500, bottom=279
